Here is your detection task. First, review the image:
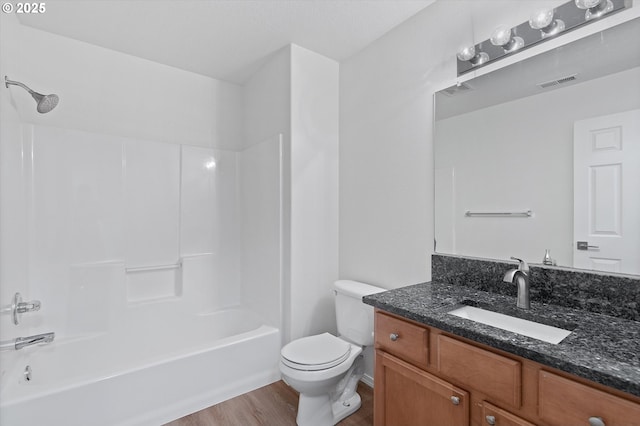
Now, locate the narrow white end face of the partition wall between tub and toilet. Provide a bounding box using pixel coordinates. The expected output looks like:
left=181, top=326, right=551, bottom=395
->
left=290, top=45, right=339, bottom=339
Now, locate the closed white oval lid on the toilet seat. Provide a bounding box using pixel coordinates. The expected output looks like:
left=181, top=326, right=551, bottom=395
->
left=281, top=333, right=351, bottom=371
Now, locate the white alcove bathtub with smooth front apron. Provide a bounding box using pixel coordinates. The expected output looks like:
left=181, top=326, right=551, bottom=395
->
left=0, top=309, right=280, bottom=426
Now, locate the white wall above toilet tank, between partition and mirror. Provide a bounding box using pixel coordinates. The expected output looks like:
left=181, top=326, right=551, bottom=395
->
left=340, top=2, right=456, bottom=288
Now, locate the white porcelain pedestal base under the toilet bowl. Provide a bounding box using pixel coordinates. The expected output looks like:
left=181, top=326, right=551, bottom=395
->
left=296, top=393, right=362, bottom=426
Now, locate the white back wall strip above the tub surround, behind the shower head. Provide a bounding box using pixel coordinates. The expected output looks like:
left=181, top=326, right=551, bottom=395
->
left=0, top=13, right=242, bottom=149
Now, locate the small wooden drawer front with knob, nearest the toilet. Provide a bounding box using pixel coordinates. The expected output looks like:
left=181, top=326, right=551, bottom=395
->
left=376, top=313, right=429, bottom=366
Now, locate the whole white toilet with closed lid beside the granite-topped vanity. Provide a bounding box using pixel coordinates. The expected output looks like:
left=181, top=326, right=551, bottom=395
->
left=280, top=280, right=385, bottom=426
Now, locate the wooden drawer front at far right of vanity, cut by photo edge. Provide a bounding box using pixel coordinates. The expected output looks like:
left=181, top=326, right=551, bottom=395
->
left=538, top=370, right=640, bottom=426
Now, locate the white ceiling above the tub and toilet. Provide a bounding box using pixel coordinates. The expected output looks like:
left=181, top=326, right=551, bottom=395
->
left=17, top=0, right=435, bottom=84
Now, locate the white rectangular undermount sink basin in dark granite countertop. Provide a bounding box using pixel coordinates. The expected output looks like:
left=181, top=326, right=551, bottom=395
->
left=447, top=306, right=571, bottom=344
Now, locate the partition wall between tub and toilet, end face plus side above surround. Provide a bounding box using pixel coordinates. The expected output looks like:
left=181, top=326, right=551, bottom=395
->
left=244, top=45, right=338, bottom=342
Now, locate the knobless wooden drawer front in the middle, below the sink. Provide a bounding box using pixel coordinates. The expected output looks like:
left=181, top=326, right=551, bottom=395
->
left=437, top=335, right=522, bottom=408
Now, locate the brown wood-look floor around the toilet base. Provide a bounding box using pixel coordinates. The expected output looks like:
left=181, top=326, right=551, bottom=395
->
left=166, top=380, right=373, bottom=426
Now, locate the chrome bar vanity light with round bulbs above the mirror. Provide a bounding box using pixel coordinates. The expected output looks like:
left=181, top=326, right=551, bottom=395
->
left=456, top=0, right=631, bottom=76
